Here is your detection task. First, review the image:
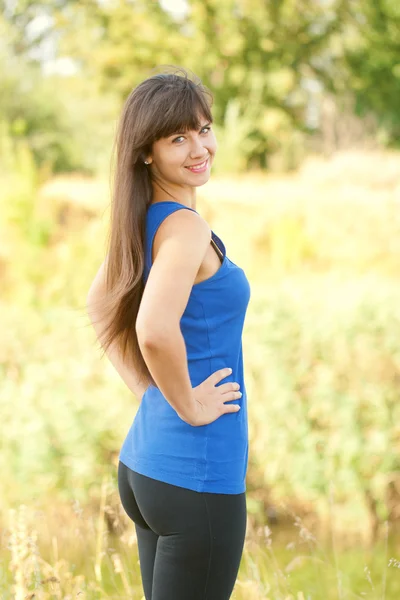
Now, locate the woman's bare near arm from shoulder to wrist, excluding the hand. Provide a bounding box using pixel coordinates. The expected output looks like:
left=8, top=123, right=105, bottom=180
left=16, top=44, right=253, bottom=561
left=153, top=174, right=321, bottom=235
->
left=136, top=210, right=211, bottom=425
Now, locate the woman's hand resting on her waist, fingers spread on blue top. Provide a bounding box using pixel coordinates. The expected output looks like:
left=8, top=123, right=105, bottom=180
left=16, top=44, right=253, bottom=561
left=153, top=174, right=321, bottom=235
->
left=190, top=369, right=242, bottom=427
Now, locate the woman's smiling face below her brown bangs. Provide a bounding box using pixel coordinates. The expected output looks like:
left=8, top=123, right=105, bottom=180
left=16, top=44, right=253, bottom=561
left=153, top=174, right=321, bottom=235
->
left=147, top=118, right=217, bottom=186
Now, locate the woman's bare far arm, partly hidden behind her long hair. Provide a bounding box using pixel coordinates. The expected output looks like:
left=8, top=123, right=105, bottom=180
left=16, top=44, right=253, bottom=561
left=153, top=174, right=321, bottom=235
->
left=86, top=262, right=147, bottom=401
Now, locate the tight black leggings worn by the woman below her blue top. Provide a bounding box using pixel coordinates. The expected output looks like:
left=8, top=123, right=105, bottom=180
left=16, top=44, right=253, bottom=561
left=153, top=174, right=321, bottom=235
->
left=118, top=462, right=246, bottom=600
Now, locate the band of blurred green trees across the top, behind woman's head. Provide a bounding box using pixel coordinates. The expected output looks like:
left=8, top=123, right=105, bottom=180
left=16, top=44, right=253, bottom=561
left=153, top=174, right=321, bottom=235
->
left=0, top=0, right=400, bottom=172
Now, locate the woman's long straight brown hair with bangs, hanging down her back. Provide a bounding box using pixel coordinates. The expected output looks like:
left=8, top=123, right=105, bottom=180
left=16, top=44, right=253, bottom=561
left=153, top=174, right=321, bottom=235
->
left=92, top=66, right=213, bottom=385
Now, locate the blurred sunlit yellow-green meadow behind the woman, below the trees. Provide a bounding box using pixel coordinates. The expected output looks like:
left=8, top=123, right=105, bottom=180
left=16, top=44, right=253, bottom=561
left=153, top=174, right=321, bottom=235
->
left=0, top=149, right=400, bottom=600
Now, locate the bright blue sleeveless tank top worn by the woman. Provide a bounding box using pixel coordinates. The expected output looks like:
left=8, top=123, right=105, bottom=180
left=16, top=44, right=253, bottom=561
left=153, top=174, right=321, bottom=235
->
left=119, top=201, right=250, bottom=494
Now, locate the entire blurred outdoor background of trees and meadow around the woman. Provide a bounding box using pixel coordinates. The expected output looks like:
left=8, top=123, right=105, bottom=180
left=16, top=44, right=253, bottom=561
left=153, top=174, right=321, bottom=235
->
left=0, top=0, right=400, bottom=600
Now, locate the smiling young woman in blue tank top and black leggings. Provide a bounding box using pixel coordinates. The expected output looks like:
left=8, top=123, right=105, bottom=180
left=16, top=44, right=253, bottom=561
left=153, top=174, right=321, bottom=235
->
left=88, top=69, right=250, bottom=600
